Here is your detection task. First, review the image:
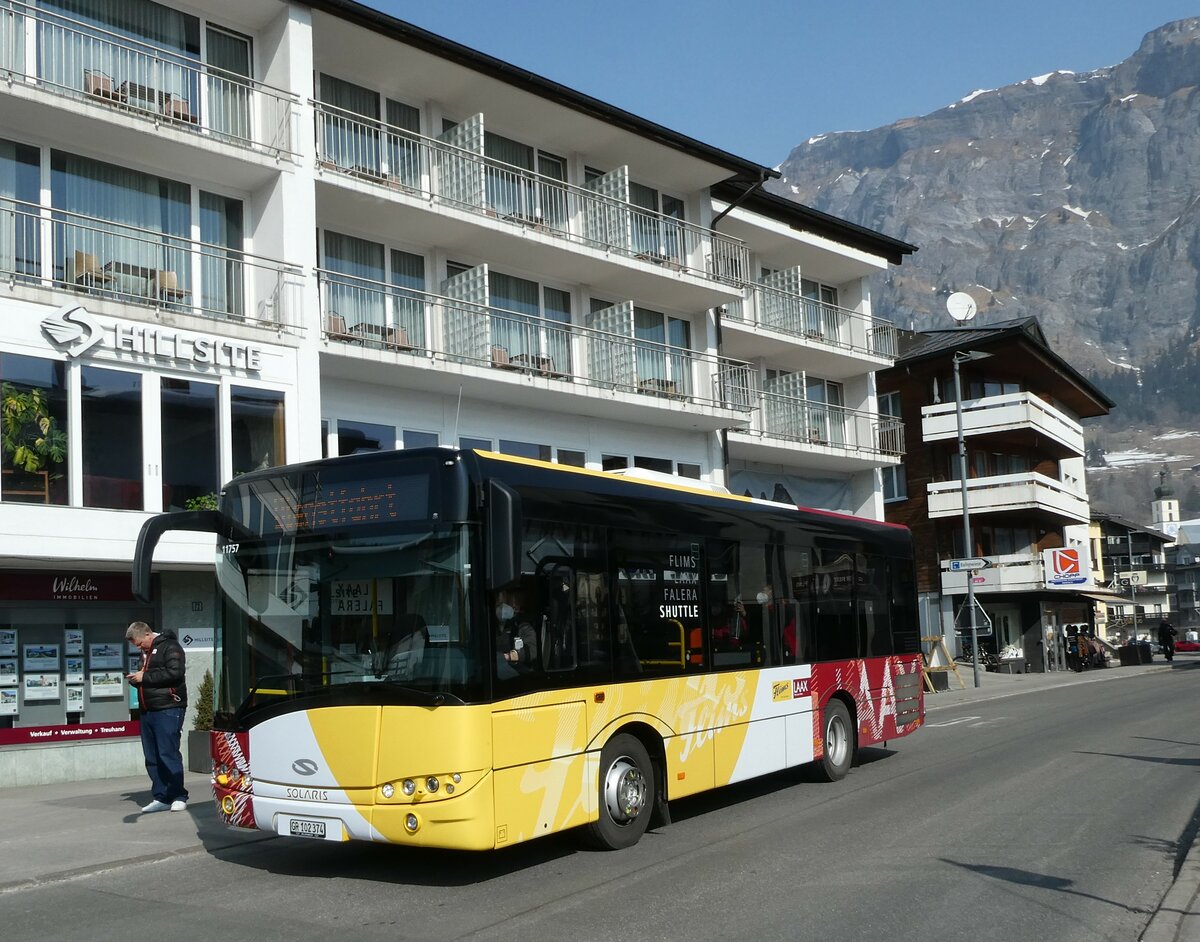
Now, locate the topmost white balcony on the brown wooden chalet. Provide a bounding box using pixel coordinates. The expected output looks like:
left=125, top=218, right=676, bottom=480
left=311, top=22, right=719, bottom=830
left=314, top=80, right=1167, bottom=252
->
left=920, top=392, right=1084, bottom=458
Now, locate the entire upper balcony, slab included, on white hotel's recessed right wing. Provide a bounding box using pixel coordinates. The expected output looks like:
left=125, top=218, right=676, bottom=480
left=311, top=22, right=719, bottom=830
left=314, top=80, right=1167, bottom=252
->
left=721, top=284, right=896, bottom=379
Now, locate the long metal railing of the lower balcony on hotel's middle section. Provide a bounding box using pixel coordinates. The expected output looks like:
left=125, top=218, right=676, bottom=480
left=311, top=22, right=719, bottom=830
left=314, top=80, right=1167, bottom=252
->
left=317, top=269, right=754, bottom=412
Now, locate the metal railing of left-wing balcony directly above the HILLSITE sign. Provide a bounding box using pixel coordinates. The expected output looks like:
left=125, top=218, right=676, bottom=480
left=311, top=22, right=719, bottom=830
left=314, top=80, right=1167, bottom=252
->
left=0, top=198, right=304, bottom=331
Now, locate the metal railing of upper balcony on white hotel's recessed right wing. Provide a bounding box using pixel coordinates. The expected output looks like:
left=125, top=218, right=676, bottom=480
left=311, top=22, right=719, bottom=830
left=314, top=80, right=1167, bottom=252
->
left=722, top=284, right=898, bottom=361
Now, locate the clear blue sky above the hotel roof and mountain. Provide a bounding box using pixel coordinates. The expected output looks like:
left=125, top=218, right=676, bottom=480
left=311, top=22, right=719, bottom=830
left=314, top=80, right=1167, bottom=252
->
left=364, top=0, right=1200, bottom=166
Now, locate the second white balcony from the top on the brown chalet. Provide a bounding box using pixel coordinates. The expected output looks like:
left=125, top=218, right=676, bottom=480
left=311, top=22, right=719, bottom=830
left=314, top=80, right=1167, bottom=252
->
left=928, top=472, right=1088, bottom=524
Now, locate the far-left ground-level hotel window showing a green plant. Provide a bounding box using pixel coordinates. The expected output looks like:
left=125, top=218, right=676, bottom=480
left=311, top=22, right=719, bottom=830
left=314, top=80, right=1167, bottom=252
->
left=0, top=353, right=71, bottom=504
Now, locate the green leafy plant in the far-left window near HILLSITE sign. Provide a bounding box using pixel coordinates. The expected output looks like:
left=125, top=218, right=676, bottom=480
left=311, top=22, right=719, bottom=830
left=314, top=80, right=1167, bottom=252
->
left=0, top=383, right=67, bottom=503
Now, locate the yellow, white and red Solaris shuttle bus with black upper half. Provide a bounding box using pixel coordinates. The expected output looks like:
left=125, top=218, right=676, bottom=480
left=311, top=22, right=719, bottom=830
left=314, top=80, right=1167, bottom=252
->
left=133, top=448, right=924, bottom=850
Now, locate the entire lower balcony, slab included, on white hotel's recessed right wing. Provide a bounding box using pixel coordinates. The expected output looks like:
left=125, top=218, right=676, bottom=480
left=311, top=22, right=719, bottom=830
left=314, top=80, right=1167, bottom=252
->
left=728, top=391, right=904, bottom=472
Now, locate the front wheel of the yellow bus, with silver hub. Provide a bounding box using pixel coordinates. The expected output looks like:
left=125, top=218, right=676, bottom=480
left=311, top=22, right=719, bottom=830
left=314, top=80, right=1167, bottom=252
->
left=586, top=733, right=655, bottom=851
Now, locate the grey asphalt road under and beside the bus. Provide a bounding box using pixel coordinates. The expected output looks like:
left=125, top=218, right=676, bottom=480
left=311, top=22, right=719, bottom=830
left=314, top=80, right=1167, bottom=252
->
left=0, top=664, right=1200, bottom=942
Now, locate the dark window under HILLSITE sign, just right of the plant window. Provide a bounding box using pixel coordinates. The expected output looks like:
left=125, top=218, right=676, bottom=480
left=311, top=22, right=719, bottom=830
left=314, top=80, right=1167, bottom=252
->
left=79, top=366, right=143, bottom=510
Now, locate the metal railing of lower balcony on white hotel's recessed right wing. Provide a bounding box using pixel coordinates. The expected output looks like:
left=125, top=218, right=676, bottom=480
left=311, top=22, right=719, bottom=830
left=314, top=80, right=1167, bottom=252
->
left=739, top=391, right=904, bottom=457
